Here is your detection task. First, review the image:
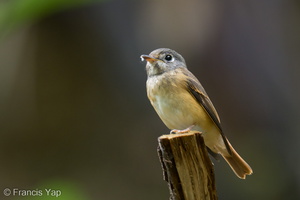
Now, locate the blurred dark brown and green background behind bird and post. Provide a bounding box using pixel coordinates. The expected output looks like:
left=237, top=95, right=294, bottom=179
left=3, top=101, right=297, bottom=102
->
left=0, top=0, right=300, bottom=200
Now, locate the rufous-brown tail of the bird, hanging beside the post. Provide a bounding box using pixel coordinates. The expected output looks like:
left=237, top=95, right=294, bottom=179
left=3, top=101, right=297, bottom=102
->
left=221, top=140, right=253, bottom=179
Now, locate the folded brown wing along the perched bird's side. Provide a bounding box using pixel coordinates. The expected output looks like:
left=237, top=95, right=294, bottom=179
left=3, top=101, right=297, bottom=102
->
left=185, top=71, right=231, bottom=154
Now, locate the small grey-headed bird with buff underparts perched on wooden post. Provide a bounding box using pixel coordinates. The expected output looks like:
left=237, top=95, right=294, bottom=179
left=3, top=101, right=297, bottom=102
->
left=141, top=48, right=252, bottom=179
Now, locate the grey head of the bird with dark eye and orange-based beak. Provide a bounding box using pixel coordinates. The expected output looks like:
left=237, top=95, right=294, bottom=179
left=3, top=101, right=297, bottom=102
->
left=141, top=48, right=186, bottom=76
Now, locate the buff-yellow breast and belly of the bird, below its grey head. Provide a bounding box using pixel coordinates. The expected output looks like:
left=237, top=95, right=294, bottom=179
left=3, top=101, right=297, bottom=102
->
left=147, top=73, right=208, bottom=131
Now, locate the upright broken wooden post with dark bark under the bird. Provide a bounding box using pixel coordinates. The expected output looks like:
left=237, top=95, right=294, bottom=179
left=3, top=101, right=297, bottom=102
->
left=158, top=132, right=218, bottom=200
